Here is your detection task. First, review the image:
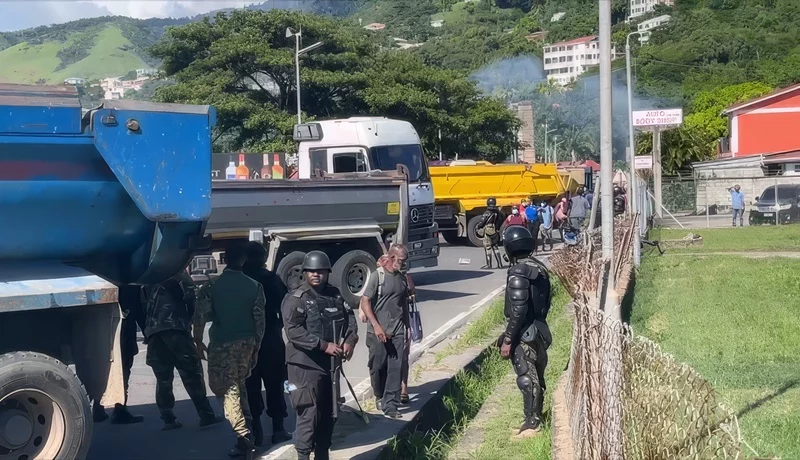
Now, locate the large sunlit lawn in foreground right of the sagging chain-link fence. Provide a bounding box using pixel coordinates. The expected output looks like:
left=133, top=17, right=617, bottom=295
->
left=631, top=253, right=800, bottom=459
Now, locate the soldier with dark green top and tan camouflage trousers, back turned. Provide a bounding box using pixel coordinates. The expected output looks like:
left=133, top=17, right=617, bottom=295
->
left=193, top=241, right=266, bottom=460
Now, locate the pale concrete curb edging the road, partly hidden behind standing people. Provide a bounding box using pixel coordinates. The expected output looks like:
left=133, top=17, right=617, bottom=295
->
left=257, top=284, right=506, bottom=460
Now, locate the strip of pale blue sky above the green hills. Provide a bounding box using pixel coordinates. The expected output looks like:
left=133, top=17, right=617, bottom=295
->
left=0, top=0, right=260, bottom=32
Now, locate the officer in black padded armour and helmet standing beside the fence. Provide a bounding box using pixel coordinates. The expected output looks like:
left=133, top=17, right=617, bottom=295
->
left=498, top=226, right=552, bottom=433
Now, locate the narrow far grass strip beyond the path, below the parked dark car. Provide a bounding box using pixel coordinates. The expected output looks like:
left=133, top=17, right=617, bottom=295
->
left=650, top=225, right=800, bottom=252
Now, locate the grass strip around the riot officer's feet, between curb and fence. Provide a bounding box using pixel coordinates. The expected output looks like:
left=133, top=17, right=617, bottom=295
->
left=379, top=280, right=572, bottom=460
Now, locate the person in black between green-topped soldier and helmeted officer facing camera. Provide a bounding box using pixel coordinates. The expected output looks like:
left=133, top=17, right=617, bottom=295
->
left=243, top=241, right=291, bottom=446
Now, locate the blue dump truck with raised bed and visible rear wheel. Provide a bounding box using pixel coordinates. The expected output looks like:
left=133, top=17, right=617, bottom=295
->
left=0, top=84, right=215, bottom=460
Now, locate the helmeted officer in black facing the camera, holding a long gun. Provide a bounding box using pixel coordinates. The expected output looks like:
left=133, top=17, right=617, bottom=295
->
left=281, top=251, right=358, bottom=460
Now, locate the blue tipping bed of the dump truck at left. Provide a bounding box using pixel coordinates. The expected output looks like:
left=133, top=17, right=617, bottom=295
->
left=0, top=84, right=215, bottom=284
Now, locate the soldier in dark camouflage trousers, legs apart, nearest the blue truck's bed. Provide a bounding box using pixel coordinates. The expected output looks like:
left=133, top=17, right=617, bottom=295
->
left=144, top=270, right=223, bottom=431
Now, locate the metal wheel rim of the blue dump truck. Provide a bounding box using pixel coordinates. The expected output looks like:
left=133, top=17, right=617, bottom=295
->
left=0, top=389, right=66, bottom=460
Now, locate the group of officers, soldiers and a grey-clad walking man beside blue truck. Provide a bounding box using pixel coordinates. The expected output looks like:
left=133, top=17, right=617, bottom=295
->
left=93, top=242, right=414, bottom=460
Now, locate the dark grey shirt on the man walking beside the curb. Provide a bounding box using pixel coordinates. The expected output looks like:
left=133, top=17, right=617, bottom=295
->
left=364, top=270, right=408, bottom=336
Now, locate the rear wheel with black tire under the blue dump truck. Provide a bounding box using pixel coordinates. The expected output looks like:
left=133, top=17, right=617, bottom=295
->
left=0, top=351, right=92, bottom=460
